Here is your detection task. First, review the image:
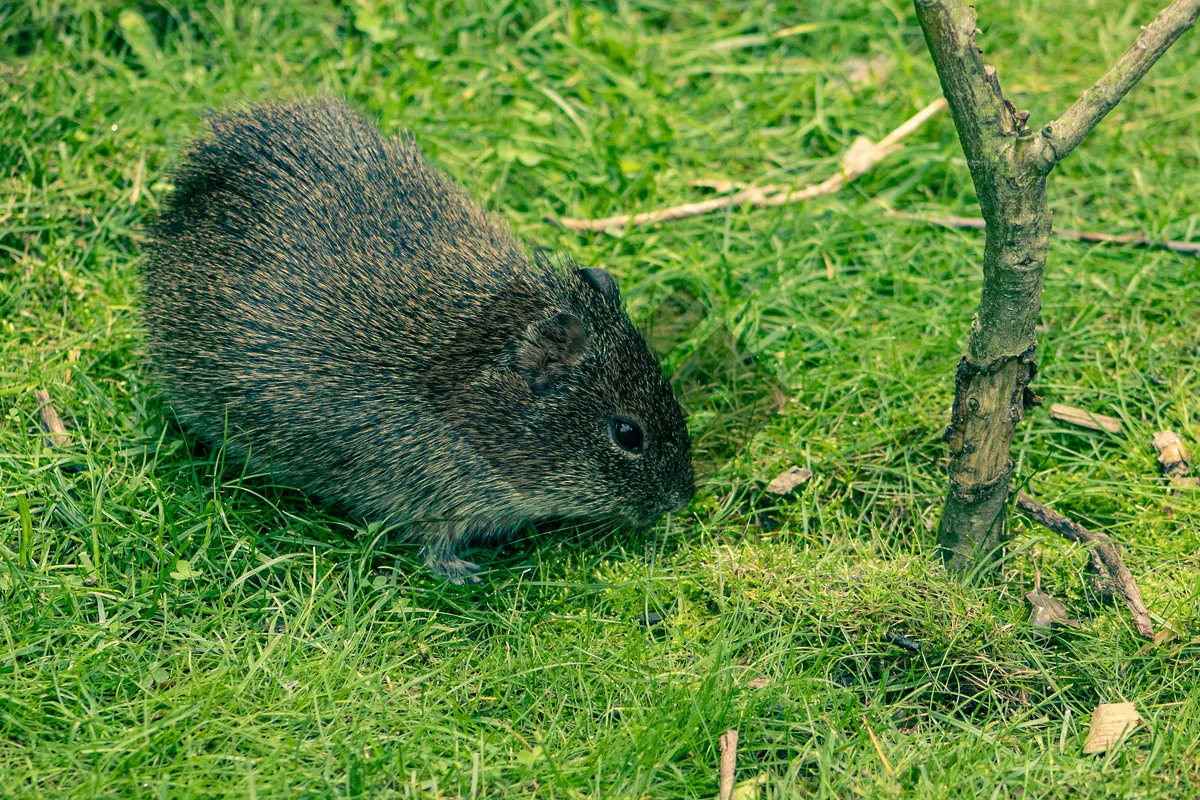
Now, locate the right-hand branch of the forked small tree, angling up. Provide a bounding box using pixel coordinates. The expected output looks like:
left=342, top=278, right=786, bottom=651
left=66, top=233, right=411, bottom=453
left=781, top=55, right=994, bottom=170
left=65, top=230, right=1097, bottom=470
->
left=1026, top=0, right=1200, bottom=174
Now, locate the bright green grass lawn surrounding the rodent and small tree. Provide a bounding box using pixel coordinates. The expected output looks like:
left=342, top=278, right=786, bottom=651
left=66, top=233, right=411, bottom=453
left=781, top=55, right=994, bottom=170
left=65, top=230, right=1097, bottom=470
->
left=0, top=0, right=1200, bottom=798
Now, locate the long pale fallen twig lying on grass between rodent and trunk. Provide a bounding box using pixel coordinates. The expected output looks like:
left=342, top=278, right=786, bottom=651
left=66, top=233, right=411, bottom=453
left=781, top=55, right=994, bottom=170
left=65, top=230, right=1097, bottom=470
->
left=546, top=98, right=946, bottom=231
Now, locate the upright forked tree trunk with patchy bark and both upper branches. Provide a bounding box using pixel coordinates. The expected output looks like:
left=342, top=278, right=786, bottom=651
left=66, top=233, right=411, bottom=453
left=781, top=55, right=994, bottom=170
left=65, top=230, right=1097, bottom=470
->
left=914, top=0, right=1200, bottom=575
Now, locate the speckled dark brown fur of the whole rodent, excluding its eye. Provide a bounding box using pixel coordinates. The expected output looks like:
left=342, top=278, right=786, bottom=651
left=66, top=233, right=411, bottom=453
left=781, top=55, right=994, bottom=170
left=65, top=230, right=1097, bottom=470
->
left=142, top=100, right=692, bottom=581
